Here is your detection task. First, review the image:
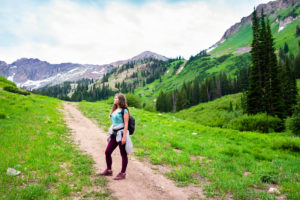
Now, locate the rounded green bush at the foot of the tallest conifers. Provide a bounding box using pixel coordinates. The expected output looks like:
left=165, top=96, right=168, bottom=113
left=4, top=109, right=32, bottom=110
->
left=227, top=113, right=284, bottom=133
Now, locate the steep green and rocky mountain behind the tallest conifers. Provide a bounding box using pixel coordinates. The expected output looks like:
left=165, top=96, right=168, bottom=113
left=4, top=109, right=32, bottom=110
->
left=208, top=0, right=300, bottom=56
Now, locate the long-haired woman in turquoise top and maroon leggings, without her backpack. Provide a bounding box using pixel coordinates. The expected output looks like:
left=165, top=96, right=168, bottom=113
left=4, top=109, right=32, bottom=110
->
left=100, top=93, right=132, bottom=180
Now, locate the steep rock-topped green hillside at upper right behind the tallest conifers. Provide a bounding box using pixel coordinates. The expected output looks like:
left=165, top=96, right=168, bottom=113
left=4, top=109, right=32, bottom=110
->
left=210, top=0, right=300, bottom=56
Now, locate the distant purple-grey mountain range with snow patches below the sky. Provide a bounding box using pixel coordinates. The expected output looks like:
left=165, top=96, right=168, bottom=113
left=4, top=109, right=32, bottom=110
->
left=0, top=51, right=167, bottom=90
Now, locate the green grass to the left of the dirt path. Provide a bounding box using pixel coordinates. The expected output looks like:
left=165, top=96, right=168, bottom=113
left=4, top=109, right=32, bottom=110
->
left=0, top=76, right=111, bottom=200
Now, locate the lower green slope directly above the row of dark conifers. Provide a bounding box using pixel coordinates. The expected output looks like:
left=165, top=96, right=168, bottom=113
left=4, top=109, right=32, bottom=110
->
left=135, top=53, right=251, bottom=105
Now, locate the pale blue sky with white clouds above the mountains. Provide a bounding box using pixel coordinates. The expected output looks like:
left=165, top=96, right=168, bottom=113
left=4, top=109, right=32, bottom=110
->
left=0, top=0, right=269, bottom=64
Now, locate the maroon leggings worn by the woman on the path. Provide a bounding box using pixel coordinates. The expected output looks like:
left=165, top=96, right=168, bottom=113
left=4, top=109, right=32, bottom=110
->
left=105, top=135, right=128, bottom=173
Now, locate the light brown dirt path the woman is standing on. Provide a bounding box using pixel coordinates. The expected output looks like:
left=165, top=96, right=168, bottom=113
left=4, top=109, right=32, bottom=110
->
left=63, top=102, right=204, bottom=200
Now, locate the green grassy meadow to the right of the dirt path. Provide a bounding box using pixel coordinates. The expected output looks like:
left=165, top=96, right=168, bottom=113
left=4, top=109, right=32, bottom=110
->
left=78, top=101, right=300, bottom=199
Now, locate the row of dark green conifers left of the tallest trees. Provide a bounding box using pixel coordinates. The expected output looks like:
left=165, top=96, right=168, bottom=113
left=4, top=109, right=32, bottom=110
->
left=156, top=68, right=248, bottom=112
